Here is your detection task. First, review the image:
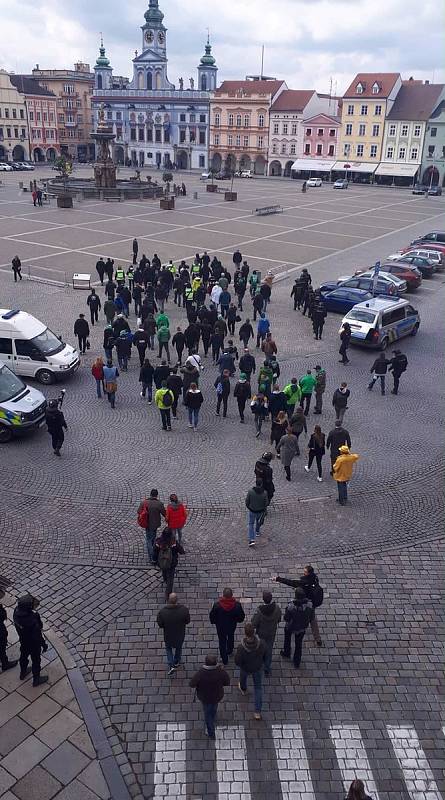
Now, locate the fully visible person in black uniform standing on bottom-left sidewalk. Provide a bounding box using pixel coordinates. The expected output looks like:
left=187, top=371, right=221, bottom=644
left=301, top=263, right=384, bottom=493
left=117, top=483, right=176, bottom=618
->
left=13, top=594, right=48, bottom=686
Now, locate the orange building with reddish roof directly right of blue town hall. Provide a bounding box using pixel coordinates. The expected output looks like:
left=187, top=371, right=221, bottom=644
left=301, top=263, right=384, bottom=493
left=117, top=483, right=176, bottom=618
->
left=209, top=79, right=287, bottom=175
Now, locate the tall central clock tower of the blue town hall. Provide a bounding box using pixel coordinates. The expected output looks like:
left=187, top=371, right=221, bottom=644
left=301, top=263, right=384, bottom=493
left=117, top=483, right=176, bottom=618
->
left=132, top=0, right=174, bottom=90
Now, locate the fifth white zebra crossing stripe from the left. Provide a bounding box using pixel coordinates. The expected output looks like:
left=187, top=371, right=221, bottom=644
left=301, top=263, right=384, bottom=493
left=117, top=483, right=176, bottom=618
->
left=386, top=725, right=441, bottom=800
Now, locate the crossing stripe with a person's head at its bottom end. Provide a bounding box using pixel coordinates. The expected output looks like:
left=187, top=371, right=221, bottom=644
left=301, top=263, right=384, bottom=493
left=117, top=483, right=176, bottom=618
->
left=329, top=725, right=379, bottom=800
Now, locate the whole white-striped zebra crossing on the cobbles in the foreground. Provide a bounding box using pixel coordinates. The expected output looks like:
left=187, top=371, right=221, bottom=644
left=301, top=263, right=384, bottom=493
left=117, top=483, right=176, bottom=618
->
left=153, top=722, right=445, bottom=800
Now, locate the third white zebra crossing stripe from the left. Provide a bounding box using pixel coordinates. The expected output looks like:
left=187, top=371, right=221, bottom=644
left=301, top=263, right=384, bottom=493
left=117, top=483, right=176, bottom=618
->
left=272, top=724, right=315, bottom=800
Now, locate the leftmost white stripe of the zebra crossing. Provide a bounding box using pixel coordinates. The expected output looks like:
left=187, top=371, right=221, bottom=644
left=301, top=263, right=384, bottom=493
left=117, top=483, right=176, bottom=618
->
left=153, top=722, right=187, bottom=798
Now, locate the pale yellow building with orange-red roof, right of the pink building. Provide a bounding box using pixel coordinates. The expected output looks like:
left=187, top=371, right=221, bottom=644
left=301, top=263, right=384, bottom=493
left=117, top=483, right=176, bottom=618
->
left=335, top=72, right=402, bottom=177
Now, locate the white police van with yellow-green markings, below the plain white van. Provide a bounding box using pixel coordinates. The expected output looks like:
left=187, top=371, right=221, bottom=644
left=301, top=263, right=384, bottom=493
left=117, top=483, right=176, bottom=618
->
left=0, top=361, right=46, bottom=444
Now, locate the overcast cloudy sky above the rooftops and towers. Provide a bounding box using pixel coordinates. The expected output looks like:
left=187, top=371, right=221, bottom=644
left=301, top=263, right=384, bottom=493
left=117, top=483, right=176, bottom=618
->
left=0, top=0, right=445, bottom=95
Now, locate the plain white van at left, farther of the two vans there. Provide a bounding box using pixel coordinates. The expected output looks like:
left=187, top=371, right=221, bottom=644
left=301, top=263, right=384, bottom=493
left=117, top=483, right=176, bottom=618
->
left=0, top=308, right=80, bottom=384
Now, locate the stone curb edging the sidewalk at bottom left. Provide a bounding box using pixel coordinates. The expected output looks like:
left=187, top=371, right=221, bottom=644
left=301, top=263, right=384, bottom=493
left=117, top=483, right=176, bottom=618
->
left=45, top=628, right=131, bottom=800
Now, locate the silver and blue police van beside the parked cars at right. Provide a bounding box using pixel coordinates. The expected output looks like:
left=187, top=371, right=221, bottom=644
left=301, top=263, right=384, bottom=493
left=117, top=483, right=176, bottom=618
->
left=340, top=297, right=420, bottom=350
